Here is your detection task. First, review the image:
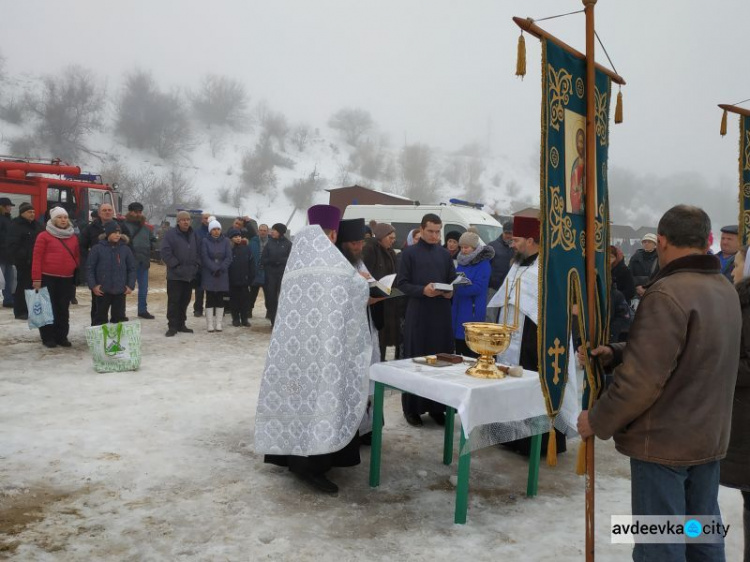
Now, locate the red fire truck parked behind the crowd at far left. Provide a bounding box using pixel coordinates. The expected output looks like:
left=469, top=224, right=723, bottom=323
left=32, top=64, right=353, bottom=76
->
left=0, top=157, right=122, bottom=225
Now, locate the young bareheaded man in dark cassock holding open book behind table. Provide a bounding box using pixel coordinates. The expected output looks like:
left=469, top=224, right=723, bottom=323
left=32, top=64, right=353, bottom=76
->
left=396, top=213, right=456, bottom=426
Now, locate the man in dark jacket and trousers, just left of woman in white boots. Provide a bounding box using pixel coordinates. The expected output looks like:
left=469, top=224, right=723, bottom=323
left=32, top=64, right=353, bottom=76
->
left=161, top=211, right=200, bottom=332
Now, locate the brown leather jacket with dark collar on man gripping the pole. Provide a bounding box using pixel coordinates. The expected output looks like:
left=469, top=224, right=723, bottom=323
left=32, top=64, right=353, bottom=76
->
left=589, top=255, right=742, bottom=465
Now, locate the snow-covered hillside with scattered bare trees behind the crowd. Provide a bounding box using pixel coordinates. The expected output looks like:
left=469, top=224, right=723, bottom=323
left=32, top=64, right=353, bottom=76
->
left=0, top=70, right=539, bottom=230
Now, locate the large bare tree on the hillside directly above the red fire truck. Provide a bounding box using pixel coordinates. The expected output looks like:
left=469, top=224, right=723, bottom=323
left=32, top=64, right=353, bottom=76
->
left=26, top=66, right=105, bottom=159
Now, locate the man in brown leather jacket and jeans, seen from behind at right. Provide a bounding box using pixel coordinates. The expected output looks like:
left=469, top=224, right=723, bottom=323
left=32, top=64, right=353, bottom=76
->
left=578, top=205, right=742, bottom=561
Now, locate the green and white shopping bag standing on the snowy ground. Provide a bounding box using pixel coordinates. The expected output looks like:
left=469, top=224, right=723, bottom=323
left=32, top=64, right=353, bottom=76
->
left=86, top=322, right=141, bottom=373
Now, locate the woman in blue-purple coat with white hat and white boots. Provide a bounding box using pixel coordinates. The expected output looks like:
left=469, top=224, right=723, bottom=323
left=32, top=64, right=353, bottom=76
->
left=201, top=220, right=232, bottom=332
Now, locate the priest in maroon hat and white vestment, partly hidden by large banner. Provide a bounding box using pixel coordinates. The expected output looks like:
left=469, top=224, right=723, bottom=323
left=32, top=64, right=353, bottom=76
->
left=487, top=216, right=567, bottom=456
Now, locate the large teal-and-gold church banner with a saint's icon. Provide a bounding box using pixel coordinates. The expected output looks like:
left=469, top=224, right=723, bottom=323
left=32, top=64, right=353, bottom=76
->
left=538, top=39, right=611, bottom=417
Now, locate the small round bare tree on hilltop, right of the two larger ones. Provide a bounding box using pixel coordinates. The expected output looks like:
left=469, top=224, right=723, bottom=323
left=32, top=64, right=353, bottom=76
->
left=190, top=74, right=250, bottom=131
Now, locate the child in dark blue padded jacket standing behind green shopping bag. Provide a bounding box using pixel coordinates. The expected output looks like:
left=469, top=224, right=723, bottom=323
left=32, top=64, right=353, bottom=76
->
left=86, top=221, right=136, bottom=326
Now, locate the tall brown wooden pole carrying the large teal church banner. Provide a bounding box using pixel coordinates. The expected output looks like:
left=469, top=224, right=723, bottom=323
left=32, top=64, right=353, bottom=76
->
left=583, top=0, right=596, bottom=562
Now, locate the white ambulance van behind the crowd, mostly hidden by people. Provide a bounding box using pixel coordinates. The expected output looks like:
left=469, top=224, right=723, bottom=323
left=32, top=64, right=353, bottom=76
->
left=343, top=199, right=503, bottom=250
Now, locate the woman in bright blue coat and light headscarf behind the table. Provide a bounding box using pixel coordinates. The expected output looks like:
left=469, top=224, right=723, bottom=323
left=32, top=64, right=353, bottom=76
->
left=452, top=232, right=495, bottom=357
